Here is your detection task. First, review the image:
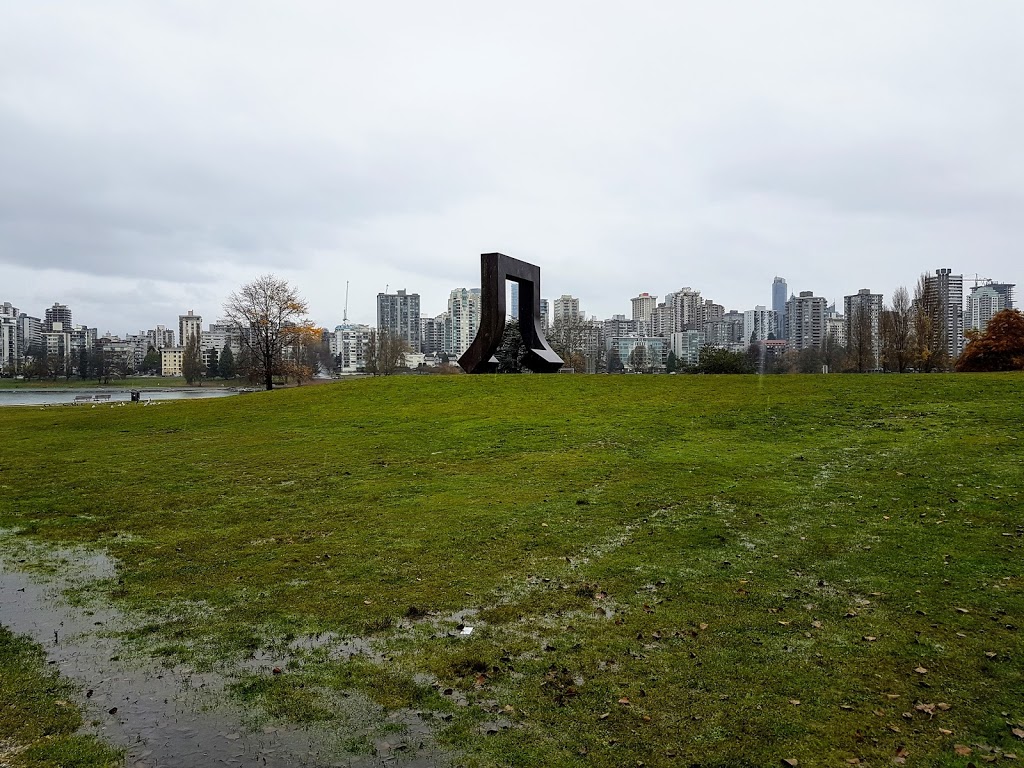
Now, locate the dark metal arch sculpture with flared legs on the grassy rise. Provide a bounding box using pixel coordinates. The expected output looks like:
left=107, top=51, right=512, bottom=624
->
left=459, top=253, right=562, bottom=374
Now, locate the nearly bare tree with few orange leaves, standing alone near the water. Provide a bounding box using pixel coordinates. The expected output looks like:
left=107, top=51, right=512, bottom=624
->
left=224, top=274, right=312, bottom=389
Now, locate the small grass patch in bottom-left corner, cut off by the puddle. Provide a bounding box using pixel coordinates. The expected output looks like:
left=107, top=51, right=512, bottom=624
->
left=0, top=627, right=121, bottom=768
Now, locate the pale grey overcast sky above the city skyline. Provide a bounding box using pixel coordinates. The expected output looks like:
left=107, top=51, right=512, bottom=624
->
left=0, top=0, right=1024, bottom=334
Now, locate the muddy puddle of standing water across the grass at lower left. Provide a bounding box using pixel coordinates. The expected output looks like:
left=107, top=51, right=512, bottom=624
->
left=0, top=552, right=447, bottom=768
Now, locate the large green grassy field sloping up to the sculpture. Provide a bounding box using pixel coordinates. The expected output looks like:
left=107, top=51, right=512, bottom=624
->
left=0, top=375, right=1024, bottom=766
